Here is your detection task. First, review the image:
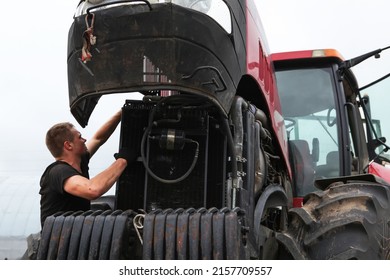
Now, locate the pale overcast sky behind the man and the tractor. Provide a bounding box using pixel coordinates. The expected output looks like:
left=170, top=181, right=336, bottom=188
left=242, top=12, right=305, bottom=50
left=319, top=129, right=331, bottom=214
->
left=0, top=0, right=390, bottom=176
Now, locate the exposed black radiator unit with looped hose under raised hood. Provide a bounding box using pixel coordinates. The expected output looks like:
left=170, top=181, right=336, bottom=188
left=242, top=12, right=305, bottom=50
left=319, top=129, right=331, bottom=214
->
left=116, top=96, right=227, bottom=212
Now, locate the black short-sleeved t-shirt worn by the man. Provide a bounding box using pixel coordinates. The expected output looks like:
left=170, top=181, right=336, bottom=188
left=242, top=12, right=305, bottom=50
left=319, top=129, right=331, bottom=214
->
left=39, top=155, right=91, bottom=228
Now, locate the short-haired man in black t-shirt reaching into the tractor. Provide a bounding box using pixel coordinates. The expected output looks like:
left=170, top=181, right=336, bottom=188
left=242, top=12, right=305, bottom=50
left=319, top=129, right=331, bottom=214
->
left=39, top=111, right=133, bottom=228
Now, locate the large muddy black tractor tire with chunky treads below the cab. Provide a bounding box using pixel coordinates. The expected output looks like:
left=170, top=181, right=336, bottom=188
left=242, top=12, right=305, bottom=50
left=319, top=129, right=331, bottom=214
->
left=277, top=181, right=390, bottom=260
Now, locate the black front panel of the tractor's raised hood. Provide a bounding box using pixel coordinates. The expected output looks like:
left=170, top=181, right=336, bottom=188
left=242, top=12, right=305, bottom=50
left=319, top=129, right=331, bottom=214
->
left=68, top=4, right=245, bottom=127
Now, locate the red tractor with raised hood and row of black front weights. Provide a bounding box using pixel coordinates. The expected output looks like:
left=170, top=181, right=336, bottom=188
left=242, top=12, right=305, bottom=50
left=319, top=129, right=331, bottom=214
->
left=37, top=0, right=390, bottom=260
